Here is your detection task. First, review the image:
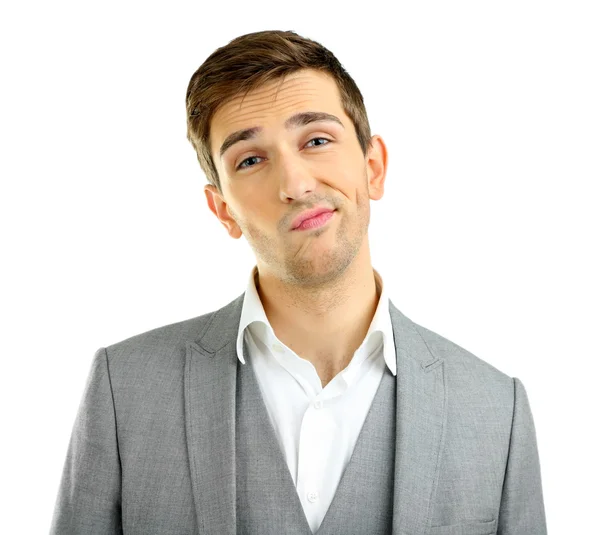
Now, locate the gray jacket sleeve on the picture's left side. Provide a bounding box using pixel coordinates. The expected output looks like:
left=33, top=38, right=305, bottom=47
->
left=50, top=348, right=123, bottom=535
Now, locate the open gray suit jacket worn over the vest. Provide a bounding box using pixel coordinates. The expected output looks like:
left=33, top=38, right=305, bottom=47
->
left=50, top=294, right=546, bottom=535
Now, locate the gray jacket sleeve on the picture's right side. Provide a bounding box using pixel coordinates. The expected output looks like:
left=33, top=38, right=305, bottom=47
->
left=498, top=377, right=547, bottom=535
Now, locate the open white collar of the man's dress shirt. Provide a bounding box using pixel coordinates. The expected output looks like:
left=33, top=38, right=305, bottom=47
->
left=236, top=266, right=396, bottom=375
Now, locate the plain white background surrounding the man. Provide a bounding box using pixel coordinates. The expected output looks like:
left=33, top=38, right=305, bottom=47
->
left=0, top=0, right=600, bottom=535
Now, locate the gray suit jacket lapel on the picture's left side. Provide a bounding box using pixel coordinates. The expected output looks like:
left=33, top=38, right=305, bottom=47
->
left=184, top=294, right=244, bottom=535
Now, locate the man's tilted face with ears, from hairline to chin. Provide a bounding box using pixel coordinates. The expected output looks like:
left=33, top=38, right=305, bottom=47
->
left=205, top=70, right=387, bottom=287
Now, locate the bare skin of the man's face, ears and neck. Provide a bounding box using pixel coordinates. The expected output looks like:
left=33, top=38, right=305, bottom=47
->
left=204, top=69, right=387, bottom=386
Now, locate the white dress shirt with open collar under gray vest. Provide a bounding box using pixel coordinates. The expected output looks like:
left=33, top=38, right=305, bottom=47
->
left=237, top=266, right=396, bottom=533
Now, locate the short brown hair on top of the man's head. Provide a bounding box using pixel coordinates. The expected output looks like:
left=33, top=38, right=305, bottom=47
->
left=185, top=30, right=371, bottom=194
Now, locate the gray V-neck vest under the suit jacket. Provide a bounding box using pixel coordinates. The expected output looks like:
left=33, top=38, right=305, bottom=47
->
left=235, top=353, right=396, bottom=535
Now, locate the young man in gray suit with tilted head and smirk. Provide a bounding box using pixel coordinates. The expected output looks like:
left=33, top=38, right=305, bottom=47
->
left=52, top=31, right=546, bottom=535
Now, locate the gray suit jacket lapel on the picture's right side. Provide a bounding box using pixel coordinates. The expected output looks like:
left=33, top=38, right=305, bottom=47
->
left=390, top=301, right=446, bottom=535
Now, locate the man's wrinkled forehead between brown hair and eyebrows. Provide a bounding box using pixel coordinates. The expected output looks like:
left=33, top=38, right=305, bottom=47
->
left=210, top=69, right=350, bottom=156
